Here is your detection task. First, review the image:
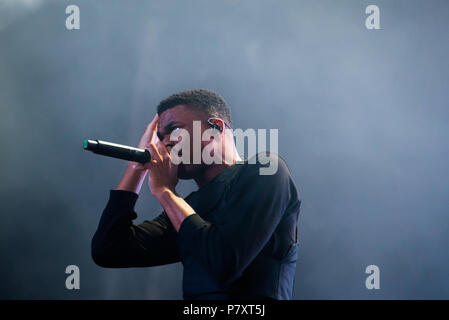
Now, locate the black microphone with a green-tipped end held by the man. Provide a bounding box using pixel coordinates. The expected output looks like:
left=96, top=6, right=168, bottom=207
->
left=83, top=139, right=151, bottom=164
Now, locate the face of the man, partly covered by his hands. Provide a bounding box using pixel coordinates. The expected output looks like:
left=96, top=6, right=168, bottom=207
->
left=157, top=105, right=214, bottom=179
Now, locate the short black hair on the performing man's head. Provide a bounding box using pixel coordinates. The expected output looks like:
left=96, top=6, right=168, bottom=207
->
left=157, top=89, right=232, bottom=127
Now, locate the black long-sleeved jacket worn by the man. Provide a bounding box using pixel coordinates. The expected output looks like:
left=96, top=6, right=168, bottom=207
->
left=92, top=154, right=301, bottom=299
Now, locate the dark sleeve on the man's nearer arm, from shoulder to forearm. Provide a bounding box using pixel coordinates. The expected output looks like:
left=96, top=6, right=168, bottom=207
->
left=178, top=158, right=290, bottom=284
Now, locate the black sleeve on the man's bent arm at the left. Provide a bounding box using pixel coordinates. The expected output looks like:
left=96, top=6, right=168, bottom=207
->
left=91, top=190, right=180, bottom=268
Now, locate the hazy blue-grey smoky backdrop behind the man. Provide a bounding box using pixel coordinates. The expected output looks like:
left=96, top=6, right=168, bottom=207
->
left=0, top=0, right=449, bottom=299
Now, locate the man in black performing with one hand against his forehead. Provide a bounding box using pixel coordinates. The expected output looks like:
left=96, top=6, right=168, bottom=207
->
left=92, top=89, right=300, bottom=299
